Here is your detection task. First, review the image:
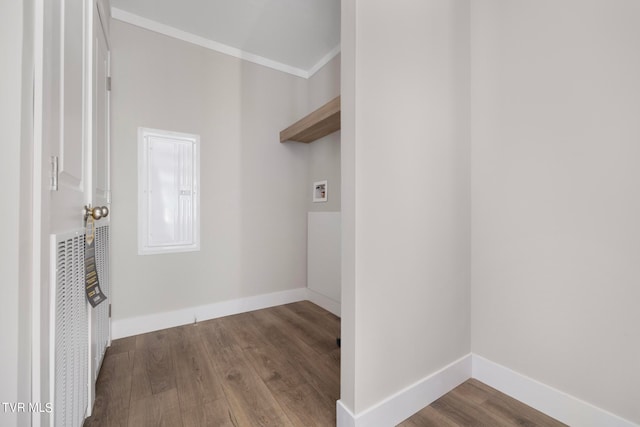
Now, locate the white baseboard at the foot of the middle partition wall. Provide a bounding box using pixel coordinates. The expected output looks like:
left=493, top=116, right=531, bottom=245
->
left=336, top=354, right=472, bottom=427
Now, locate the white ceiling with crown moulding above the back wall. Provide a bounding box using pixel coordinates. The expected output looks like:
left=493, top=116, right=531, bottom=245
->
left=111, top=0, right=340, bottom=77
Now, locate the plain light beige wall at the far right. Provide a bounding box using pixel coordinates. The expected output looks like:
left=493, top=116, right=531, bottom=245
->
left=471, top=0, right=640, bottom=423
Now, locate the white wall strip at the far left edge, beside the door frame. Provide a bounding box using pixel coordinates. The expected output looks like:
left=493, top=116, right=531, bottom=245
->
left=0, top=1, right=33, bottom=426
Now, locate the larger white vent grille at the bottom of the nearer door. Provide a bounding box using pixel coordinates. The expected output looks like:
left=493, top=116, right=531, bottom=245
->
left=53, top=233, right=89, bottom=427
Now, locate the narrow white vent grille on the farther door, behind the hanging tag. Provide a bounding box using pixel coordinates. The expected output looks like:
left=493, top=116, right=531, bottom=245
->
left=92, top=225, right=111, bottom=378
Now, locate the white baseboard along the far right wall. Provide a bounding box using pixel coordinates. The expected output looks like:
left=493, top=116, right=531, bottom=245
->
left=472, top=354, right=638, bottom=427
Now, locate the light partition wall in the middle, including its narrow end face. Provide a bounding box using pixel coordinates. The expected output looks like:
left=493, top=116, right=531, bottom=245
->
left=341, top=0, right=470, bottom=414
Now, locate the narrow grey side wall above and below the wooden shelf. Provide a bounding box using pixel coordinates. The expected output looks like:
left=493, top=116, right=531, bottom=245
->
left=306, top=55, right=342, bottom=212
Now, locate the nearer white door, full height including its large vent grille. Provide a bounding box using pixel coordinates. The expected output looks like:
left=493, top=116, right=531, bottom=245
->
left=41, top=0, right=90, bottom=426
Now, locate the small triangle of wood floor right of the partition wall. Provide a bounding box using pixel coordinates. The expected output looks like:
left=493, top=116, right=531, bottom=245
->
left=400, top=379, right=565, bottom=427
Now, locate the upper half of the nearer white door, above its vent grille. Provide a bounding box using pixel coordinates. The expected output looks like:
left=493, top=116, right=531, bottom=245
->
left=43, top=0, right=88, bottom=234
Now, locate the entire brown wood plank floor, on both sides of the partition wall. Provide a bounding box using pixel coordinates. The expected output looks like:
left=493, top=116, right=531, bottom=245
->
left=84, top=301, right=563, bottom=427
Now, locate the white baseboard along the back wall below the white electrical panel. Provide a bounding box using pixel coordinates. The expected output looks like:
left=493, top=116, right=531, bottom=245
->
left=111, top=288, right=307, bottom=339
